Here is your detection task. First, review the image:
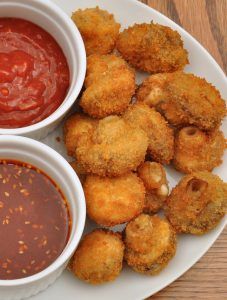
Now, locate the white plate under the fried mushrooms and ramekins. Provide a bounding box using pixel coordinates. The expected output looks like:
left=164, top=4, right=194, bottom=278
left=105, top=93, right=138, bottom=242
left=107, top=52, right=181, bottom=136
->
left=32, top=0, right=227, bottom=300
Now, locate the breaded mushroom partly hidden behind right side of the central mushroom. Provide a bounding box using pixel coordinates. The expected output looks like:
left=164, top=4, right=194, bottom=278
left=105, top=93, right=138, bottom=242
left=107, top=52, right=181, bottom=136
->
left=124, top=103, right=174, bottom=164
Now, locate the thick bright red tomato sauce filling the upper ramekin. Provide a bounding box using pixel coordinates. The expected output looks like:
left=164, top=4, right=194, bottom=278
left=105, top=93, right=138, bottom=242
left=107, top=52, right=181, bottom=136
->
left=0, top=18, right=69, bottom=128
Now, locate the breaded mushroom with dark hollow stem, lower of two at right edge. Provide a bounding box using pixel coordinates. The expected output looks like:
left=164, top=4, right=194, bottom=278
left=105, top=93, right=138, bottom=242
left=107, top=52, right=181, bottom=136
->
left=165, top=171, right=227, bottom=234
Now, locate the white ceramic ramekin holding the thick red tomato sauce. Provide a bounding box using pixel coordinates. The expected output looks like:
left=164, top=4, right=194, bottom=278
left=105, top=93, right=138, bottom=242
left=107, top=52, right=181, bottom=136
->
left=0, top=0, right=86, bottom=139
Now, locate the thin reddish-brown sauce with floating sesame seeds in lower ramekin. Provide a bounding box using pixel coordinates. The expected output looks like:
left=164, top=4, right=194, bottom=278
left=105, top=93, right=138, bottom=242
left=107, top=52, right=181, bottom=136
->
left=0, top=160, right=70, bottom=280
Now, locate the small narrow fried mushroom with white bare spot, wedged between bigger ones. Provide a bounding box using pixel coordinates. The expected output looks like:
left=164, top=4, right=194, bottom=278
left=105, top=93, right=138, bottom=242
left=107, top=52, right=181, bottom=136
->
left=137, top=161, right=169, bottom=214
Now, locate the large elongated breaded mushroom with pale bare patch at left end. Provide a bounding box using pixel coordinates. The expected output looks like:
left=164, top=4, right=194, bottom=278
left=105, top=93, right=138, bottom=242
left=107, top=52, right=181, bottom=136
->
left=137, top=72, right=226, bottom=130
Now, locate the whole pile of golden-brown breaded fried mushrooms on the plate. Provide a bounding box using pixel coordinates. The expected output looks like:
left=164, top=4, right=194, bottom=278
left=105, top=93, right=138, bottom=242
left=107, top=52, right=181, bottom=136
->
left=64, top=7, right=227, bottom=284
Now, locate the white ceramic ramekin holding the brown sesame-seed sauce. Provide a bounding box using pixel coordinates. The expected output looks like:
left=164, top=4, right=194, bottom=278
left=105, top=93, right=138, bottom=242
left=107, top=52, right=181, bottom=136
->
left=0, top=135, right=86, bottom=300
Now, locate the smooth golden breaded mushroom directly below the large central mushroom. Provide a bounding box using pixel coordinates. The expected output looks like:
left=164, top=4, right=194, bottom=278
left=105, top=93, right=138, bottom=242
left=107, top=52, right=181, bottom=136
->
left=84, top=172, right=145, bottom=226
